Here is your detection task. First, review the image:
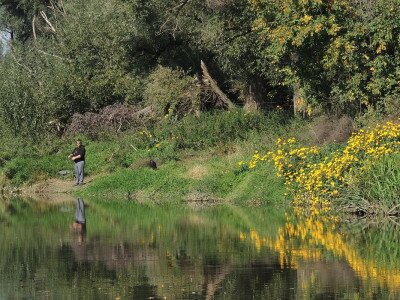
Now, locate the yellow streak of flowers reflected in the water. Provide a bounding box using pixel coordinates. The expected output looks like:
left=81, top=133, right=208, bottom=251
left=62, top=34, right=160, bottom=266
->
left=239, top=218, right=400, bottom=290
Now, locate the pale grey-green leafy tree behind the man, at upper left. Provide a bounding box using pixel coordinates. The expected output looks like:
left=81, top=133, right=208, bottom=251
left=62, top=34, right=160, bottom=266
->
left=0, top=0, right=148, bottom=134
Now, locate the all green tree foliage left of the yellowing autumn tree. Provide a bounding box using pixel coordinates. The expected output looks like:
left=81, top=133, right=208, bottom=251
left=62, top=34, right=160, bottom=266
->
left=0, top=0, right=296, bottom=139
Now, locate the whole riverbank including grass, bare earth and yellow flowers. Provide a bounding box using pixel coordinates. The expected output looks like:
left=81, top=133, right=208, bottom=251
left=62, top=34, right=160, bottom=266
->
left=1, top=112, right=400, bottom=216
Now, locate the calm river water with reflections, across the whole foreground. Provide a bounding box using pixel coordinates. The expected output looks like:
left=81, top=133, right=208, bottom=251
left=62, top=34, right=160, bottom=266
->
left=0, top=198, right=400, bottom=299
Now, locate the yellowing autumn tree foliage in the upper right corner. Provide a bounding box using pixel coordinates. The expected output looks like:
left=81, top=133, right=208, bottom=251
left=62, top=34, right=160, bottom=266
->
left=251, top=0, right=400, bottom=115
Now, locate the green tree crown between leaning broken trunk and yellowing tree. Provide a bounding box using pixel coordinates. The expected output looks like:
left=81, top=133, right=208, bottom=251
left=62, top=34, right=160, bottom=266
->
left=150, top=0, right=287, bottom=108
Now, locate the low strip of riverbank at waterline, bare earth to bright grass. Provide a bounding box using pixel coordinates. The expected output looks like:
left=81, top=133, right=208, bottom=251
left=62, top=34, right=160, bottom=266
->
left=4, top=153, right=286, bottom=206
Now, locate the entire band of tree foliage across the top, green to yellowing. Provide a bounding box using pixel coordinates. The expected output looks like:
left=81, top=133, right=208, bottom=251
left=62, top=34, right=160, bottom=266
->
left=0, top=0, right=400, bottom=135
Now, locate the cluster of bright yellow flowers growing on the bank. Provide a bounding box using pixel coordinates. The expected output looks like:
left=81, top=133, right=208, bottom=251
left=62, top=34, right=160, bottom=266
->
left=239, top=122, right=400, bottom=214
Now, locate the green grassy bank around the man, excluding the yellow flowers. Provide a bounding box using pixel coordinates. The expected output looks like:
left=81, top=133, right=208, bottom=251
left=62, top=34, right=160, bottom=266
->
left=1, top=110, right=309, bottom=205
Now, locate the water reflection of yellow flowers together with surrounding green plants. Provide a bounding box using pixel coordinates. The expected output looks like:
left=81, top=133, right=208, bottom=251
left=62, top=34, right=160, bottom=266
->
left=239, top=217, right=400, bottom=299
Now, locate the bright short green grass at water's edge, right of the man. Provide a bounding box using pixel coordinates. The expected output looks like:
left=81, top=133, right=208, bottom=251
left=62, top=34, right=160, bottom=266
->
left=79, top=153, right=285, bottom=204
